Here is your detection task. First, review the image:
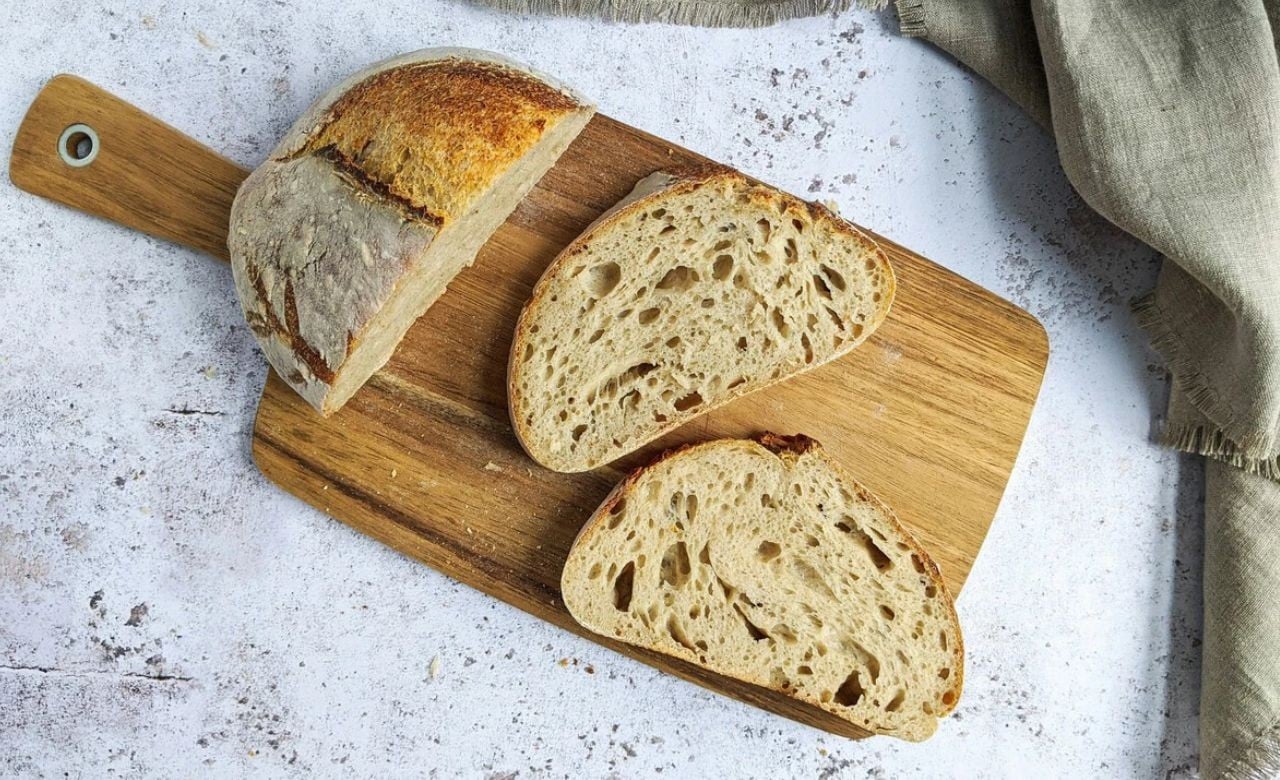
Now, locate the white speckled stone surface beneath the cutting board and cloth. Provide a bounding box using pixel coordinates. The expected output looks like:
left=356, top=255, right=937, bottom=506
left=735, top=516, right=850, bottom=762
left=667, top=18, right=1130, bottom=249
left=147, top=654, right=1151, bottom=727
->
left=0, top=0, right=1202, bottom=780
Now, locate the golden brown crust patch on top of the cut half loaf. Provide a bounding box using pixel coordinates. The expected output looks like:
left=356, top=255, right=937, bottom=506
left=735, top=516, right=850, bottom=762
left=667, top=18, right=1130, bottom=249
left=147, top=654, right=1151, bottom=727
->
left=300, top=59, right=582, bottom=221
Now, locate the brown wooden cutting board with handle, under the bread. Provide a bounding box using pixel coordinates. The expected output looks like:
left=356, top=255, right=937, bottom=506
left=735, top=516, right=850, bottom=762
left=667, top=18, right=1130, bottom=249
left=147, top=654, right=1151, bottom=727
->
left=10, top=76, right=1048, bottom=736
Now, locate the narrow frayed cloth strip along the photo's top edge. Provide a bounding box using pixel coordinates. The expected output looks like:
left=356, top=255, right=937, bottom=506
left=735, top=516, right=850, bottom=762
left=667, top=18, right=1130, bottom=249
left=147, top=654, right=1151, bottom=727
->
left=483, top=0, right=887, bottom=27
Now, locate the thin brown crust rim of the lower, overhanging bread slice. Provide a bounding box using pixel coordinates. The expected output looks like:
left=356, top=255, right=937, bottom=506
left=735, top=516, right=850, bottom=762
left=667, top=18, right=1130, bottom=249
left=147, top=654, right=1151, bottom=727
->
left=561, top=432, right=964, bottom=742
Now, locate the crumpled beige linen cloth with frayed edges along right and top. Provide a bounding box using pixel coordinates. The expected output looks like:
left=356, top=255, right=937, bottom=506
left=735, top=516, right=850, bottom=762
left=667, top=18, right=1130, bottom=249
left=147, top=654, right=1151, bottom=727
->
left=480, top=0, right=1280, bottom=777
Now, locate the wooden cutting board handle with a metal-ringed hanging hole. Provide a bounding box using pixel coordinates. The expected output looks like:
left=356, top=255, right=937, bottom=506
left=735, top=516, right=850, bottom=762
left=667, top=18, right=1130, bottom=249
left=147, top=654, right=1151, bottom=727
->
left=9, top=74, right=248, bottom=260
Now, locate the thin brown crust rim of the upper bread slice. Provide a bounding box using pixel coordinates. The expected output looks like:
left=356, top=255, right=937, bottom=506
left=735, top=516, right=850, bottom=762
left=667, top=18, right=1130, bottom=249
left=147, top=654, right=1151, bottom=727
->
left=507, top=161, right=897, bottom=471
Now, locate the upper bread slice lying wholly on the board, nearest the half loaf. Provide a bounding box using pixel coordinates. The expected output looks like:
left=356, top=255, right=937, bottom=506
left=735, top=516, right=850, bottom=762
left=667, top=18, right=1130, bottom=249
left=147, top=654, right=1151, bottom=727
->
left=508, top=165, right=895, bottom=471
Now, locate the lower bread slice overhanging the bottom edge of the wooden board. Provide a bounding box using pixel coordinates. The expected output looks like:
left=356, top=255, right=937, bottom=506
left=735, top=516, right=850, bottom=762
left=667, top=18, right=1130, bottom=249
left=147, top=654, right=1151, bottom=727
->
left=561, top=434, right=964, bottom=740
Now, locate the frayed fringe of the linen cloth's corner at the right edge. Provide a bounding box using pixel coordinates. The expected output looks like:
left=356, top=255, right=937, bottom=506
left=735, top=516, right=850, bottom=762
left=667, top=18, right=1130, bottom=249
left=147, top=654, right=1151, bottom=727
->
left=1133, top=293, right=1280, bottom=480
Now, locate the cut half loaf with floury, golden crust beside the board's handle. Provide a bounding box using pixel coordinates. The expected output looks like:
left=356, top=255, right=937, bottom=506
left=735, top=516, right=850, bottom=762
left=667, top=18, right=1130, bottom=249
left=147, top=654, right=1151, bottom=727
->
left=229, top=49, right=593, bottom=415
